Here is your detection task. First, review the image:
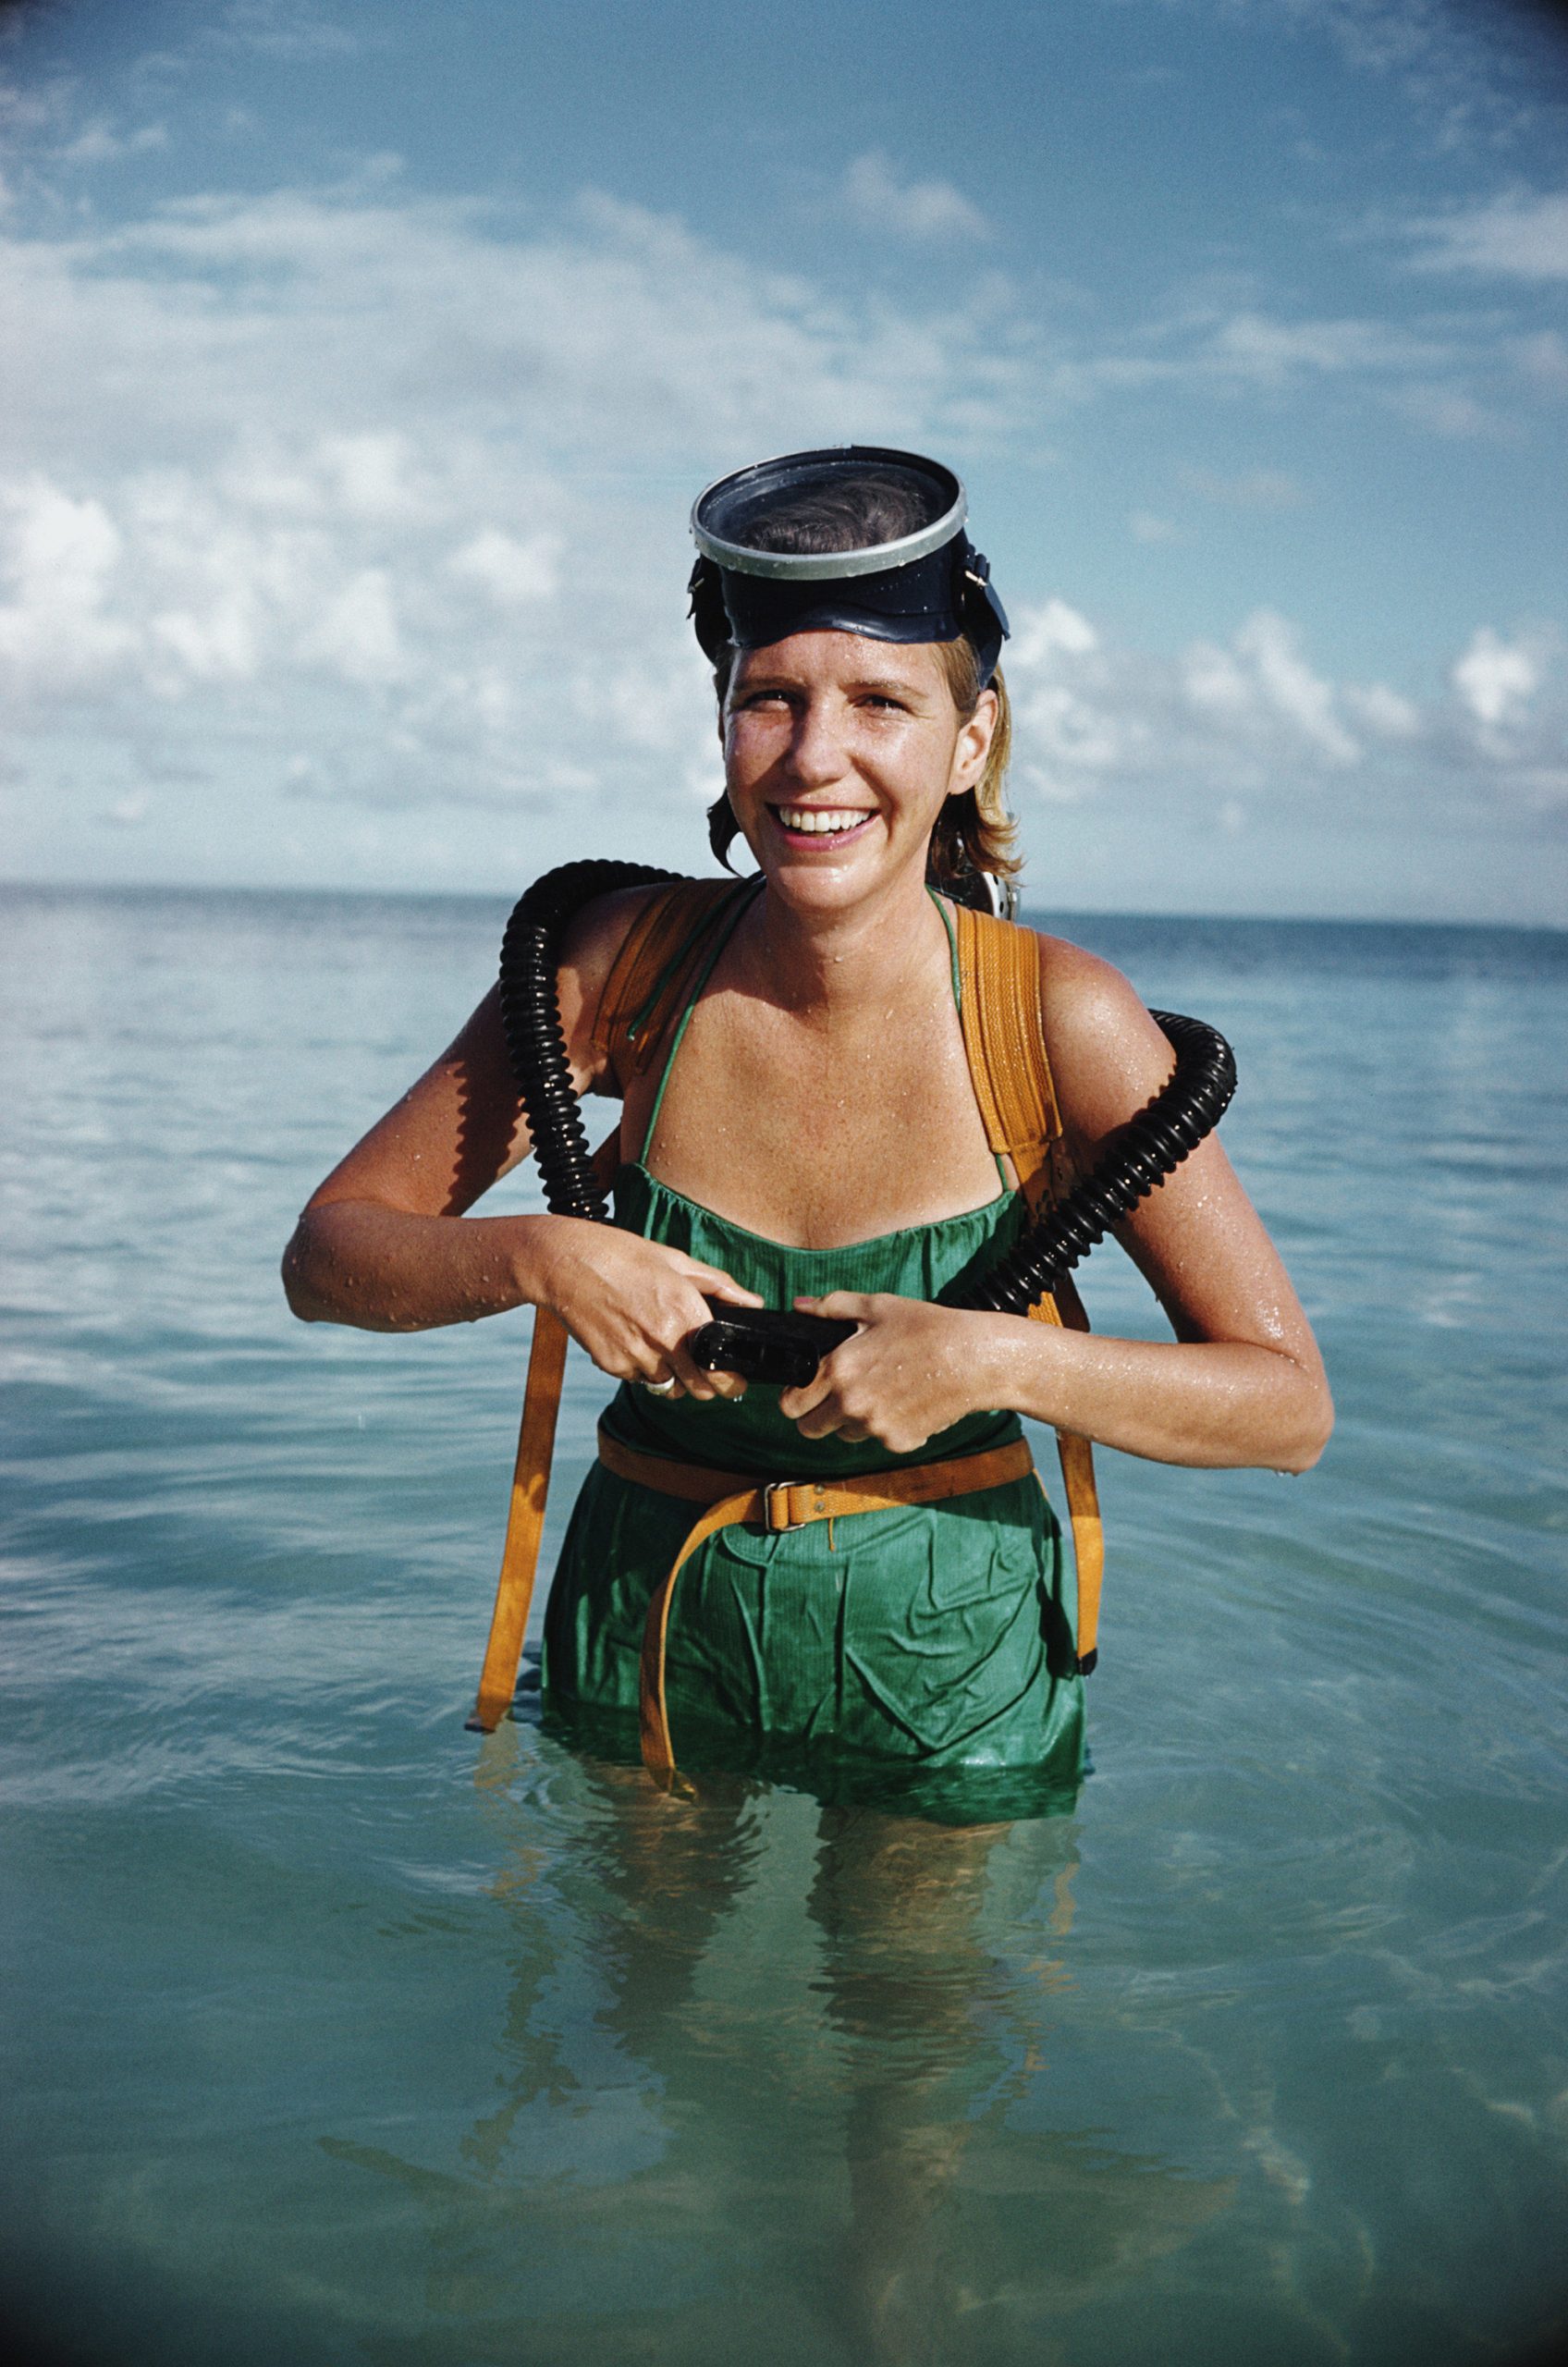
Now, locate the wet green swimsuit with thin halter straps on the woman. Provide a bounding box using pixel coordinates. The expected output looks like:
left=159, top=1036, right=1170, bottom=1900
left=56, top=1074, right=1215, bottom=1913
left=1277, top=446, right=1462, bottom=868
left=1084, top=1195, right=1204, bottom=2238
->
left=545, top=897, right=1083, bottom=1816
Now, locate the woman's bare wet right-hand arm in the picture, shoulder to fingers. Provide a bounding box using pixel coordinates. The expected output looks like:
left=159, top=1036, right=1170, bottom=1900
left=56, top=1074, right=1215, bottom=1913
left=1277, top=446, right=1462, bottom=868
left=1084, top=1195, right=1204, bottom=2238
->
left=784, top=939, right=1333, bottom=1470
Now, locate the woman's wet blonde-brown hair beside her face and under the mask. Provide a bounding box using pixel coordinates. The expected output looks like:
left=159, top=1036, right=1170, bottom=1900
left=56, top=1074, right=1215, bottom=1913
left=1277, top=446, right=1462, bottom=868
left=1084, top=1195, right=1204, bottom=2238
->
left=708, top=473, right=1023, bottom=888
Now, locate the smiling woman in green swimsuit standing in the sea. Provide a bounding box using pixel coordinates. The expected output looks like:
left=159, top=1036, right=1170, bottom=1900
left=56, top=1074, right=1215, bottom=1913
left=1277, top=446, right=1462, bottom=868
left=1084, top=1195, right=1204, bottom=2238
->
left=284, top=448, right=1331, bottom=1808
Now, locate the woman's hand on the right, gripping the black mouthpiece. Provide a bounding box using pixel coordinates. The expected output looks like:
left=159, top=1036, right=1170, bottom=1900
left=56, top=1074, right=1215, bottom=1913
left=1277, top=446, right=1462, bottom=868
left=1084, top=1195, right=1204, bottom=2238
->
left=779, top=1290, right=998, bottom=1455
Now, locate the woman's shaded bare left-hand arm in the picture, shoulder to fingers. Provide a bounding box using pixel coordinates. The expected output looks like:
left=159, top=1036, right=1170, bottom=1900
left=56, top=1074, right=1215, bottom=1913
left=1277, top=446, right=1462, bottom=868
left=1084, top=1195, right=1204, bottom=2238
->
left=284, top=895, right=755, bottom=1396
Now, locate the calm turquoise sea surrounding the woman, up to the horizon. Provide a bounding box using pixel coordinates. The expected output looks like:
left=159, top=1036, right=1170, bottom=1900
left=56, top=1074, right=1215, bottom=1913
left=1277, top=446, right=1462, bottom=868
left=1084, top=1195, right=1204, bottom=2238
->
left=0, top=890, right=1568, bottom=2367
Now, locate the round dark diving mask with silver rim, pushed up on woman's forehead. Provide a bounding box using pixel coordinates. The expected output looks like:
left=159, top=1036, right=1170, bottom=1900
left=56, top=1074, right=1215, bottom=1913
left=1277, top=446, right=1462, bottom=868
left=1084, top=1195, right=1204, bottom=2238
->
left=692, top=445, right=1007, bottom=686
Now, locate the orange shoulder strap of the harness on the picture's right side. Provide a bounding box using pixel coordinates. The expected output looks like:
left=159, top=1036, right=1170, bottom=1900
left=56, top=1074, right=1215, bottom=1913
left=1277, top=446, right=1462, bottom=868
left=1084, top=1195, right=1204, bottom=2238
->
left=954, top=904, right=1106, bottom=1674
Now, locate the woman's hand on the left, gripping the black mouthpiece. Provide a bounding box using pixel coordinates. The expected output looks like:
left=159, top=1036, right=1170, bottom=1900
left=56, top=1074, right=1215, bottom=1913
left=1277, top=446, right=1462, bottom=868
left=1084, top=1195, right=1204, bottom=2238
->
left=526, top=1217, right=763, bottom=1399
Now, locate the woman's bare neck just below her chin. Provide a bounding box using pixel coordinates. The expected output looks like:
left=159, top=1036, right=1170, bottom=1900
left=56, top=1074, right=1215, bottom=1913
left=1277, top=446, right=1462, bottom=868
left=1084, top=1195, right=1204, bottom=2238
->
left=743, top=871, right=948, bottom=1018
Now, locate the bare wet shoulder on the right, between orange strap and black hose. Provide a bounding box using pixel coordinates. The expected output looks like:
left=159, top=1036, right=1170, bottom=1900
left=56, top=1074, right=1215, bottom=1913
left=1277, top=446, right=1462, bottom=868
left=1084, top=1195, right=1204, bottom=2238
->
left=1037, top=933, right=1175, bottom=1146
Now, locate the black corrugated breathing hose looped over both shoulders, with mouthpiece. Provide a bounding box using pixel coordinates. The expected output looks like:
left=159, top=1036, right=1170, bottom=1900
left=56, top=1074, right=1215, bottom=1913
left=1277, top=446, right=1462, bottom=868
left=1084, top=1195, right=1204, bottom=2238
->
left=500, top=859, right=1236, bottom=1325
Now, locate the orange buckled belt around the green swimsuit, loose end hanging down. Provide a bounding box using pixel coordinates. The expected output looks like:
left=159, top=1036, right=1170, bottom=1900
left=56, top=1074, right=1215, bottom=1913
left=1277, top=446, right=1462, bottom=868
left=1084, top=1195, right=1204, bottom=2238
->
left=599, top=1425, right=1035, bottom=1778
